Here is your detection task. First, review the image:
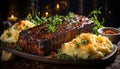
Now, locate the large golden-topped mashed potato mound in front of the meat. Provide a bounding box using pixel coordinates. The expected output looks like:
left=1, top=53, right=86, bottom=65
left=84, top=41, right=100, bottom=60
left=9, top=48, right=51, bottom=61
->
left=59, top=33, right=113, bottom=59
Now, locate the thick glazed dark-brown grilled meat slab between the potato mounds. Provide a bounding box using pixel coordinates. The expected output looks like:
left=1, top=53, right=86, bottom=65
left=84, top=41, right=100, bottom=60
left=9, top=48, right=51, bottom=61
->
left=18, top=15, right=93, bottom=56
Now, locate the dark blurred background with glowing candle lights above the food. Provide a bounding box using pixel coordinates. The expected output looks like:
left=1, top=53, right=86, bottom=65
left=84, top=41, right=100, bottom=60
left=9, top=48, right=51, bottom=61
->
left=0, top=0, right=120, bottom=35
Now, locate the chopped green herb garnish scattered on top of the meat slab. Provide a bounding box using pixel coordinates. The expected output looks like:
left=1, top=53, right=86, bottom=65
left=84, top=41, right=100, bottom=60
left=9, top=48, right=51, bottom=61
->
left=26, top=12, right=76, bottom=32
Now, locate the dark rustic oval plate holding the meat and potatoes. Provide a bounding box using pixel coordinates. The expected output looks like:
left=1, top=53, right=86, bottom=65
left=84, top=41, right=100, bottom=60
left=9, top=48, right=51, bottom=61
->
left=1, top=45, right=118, bottom=65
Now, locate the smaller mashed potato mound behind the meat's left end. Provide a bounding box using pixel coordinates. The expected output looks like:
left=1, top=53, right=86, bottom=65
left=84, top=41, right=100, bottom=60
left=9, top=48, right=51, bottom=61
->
left=0, top=20, right=35, bottom=42
